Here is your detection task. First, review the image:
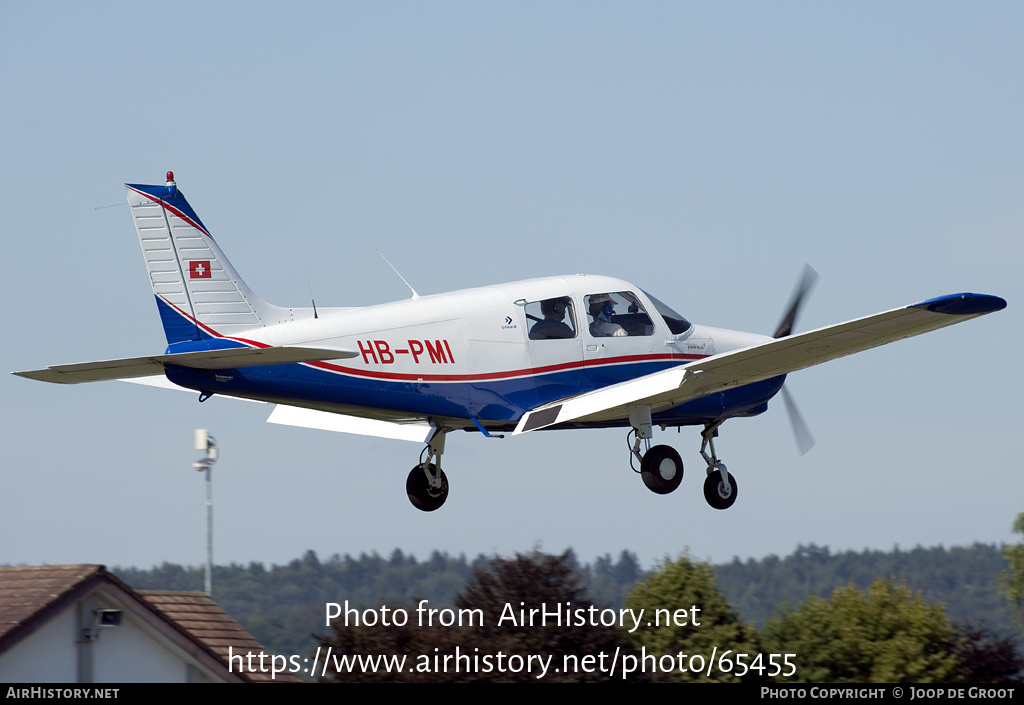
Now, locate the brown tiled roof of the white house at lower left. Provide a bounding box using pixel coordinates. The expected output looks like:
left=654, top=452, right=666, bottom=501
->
left=0, top=564, right=297, bottom=681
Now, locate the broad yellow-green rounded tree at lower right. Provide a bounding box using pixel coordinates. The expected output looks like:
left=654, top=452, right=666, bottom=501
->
left=763, top=579, right=964, bottom=682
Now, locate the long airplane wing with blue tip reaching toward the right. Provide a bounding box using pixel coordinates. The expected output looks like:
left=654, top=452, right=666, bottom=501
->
left=514, top=293, right=1007, bottom=434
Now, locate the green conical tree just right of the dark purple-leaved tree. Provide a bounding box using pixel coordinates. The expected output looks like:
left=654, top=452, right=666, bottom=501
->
left=626, top=555, right=761, bottom=682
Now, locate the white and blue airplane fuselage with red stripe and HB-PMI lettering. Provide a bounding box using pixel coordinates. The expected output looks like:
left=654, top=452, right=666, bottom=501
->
left=161, top=275, right=784, bottom=430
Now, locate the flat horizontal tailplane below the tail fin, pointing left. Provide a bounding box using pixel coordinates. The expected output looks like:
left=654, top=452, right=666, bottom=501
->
left=13, top=345, right=358, bottom=384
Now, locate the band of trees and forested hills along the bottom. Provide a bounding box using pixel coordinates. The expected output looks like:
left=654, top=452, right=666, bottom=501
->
left=114, top=544, right=1024, bottom=682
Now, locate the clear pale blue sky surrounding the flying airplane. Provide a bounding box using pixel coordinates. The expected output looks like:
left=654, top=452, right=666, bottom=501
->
left=0, top=2, right=1024, bottom=567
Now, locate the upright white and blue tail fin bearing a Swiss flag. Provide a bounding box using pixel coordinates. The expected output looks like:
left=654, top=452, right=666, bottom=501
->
left=125, top=171, right=293, bottom=344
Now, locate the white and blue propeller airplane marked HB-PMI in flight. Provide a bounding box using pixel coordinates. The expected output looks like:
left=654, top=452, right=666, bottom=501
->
left=13, top=172, right=1007, bottom=511
